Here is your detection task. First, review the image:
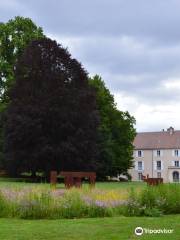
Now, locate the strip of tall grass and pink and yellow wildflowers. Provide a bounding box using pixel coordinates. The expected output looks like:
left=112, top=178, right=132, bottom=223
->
left=0, top=184, right=180, bottom=219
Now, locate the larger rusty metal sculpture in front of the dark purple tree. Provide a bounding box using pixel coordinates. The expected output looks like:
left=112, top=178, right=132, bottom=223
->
left=50, top=171, right=96, bottom=188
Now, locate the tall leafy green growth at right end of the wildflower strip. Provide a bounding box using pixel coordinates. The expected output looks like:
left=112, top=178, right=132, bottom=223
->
left=126, top=184, right=180, bottom=217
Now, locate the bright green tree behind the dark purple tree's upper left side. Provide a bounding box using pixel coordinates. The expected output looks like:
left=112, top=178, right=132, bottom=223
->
left=0, top=17, right=44, bottom=106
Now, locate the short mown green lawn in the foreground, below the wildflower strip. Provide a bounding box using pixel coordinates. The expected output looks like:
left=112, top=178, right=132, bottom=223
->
left=0, top=215, right=180, bottom=240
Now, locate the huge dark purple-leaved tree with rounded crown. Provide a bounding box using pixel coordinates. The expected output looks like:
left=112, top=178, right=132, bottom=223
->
left=4, top=39, right=99, bottom=175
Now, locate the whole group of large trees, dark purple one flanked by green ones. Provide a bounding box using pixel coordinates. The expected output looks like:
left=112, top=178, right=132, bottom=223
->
left=0, top=17, right=136, bottom=178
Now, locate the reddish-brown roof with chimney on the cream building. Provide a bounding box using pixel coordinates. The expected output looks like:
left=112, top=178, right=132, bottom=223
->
left=134, top=127, right=180, bottom=149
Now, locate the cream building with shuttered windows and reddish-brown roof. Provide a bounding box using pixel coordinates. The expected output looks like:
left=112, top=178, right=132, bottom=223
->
left=129, top=127, right=180, bottom=182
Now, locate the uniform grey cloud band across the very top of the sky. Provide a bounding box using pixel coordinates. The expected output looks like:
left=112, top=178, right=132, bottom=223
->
left=0, top=0, right=180, bottom=42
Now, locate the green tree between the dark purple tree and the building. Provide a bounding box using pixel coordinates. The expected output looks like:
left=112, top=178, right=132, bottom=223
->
left=89, top=75, right=136, bottom=177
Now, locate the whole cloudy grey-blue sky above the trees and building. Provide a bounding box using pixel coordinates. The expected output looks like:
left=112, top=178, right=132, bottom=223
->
left=0, top=0, right=180, bottom=132
